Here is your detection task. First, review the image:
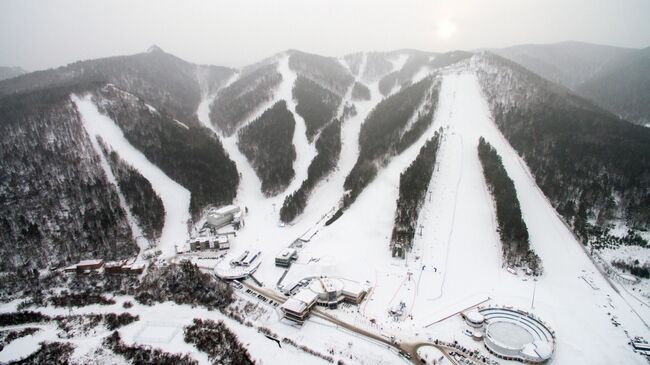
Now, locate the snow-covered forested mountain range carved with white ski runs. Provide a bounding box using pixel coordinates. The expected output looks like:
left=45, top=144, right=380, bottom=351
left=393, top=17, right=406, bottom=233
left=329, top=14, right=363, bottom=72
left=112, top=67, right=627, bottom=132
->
left=0, top=44, right=650, bottom=364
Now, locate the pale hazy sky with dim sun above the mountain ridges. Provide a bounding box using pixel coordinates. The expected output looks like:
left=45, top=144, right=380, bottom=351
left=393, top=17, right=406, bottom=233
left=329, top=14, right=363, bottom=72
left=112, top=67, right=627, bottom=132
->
left=0, top=0, right=650, bottom=70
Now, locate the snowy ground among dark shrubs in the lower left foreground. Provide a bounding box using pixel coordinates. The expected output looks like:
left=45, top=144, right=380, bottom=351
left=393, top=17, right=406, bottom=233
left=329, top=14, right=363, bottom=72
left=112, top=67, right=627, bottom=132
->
left=0, top=293, right=396, bottom=365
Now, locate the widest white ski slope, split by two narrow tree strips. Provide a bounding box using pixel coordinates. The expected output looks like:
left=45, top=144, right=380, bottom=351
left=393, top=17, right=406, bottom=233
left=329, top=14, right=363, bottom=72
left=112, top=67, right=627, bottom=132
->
left=285, top=71, right=650, bottom=364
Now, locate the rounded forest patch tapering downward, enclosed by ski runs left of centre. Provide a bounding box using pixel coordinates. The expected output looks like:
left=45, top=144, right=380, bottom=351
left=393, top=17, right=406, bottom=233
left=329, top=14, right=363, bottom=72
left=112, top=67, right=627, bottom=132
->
left=237, top=100, right=296, bottom=196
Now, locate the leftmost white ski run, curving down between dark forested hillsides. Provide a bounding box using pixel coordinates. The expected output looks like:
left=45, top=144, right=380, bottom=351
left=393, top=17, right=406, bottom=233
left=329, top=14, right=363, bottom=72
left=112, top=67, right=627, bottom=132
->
left=72, top=95, right=190, bottom=257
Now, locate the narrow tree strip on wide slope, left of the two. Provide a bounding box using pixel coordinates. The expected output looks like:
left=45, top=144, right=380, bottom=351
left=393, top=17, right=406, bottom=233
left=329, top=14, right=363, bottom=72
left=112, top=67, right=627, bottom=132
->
left=390, top=130, right=442, bottom=258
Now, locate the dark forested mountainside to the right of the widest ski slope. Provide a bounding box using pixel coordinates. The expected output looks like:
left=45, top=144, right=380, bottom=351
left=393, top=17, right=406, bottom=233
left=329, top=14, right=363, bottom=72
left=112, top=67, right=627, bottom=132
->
left=478, top=54, right=650, bottom=244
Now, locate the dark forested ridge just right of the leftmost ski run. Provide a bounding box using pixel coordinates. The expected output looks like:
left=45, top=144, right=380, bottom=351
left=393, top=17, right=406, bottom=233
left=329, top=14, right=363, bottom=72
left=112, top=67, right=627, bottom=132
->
left=94, top=86, right=239, bottom=217
